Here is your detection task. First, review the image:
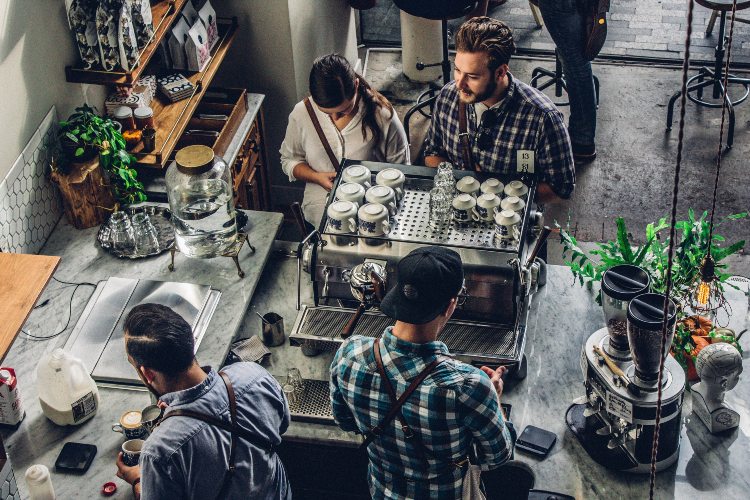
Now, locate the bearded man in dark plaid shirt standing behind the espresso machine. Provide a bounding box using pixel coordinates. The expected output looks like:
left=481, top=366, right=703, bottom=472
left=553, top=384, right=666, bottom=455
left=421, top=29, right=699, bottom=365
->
left=424, top=17, right=575, bottom=202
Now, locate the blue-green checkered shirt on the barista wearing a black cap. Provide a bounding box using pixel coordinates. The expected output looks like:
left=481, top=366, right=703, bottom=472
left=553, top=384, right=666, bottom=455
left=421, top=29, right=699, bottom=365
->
left=331, top=327, right=513, bottom=500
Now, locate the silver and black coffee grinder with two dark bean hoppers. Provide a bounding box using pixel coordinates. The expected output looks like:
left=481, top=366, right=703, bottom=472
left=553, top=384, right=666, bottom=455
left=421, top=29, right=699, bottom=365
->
left=566, top=265, right=685, bottom=473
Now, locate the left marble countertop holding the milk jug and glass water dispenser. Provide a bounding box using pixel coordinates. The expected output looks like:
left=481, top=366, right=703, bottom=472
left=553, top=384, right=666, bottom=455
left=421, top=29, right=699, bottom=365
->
left=2, top=211, right=282, bottom=498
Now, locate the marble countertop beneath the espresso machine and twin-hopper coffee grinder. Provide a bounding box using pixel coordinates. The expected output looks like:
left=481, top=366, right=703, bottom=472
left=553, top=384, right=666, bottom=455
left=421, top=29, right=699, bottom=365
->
left=248, top=255, right=750, bottom=500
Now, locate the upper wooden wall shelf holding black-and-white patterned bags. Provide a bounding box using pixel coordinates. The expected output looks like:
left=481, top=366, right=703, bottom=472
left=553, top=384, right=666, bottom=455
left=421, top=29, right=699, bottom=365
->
left=65, top=0, right=188, bottom=87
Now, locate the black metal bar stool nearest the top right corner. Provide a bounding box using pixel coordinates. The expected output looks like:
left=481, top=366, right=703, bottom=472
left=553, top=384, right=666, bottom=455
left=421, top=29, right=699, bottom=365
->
left=667, top=0, right=750, bottom=148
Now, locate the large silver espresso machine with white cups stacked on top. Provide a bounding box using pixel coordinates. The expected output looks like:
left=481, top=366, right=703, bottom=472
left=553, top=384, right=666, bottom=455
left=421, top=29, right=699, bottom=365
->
left=289, top=160, right=549, bottom=377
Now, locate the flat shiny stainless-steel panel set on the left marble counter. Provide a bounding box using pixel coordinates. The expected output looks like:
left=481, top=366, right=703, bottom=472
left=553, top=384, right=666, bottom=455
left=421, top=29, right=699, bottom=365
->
left=65, top=277, right=221, bottom=386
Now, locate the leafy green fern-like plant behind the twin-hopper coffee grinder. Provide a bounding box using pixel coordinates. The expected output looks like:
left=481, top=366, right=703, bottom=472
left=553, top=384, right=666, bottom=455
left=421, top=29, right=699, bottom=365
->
left=555, top=209, right=748, bottom=376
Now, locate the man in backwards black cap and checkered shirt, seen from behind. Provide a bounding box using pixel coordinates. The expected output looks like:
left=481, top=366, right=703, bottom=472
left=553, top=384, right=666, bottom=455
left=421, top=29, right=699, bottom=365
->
left=331, top=247, right=513, bottom=499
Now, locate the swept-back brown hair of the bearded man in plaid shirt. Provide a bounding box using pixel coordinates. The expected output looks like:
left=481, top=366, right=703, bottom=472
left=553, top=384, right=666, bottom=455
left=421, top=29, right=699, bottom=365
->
left=456, top=16, right=516, bottom=72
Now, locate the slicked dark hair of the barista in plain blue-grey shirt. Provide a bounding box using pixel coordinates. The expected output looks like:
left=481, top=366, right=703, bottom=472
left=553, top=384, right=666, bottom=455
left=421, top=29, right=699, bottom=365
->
left=124, top=304, right=195, bottom=377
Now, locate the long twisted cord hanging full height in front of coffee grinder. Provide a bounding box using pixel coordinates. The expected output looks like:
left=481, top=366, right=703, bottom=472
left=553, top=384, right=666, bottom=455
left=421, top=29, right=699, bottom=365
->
left=649, top=0, right=695, bottom=500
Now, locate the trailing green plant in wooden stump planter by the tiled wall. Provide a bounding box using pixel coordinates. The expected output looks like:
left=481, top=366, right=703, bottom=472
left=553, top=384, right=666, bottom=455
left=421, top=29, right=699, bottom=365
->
left=58, top=104, right=146, bottom=204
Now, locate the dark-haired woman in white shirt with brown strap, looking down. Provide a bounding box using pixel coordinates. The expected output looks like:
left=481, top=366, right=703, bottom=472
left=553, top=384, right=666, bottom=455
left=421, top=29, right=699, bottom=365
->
left=279, top=54, right=409, bottom=227
